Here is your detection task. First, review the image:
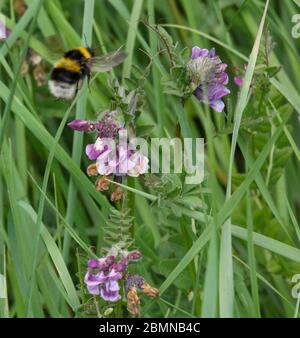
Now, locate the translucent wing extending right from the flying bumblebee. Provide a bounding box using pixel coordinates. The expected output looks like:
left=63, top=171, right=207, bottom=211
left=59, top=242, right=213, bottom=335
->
left=91, top=50, right=127, bottom=73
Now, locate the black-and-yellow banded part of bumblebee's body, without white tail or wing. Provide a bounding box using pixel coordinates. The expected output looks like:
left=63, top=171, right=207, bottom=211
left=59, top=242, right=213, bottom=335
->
left=51, top=47, right=94, bottom=84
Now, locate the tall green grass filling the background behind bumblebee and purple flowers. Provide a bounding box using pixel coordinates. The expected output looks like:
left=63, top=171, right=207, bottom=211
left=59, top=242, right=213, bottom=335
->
left=0, top=0, right=300, bottom=317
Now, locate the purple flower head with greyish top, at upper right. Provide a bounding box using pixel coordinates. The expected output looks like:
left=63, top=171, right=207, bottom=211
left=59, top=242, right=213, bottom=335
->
left=187, top=47, right=230, bottom=112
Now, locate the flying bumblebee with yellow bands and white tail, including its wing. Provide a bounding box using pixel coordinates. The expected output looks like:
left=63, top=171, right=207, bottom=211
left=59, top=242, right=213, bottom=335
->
left=48, top=47, right=127, bottom=100
